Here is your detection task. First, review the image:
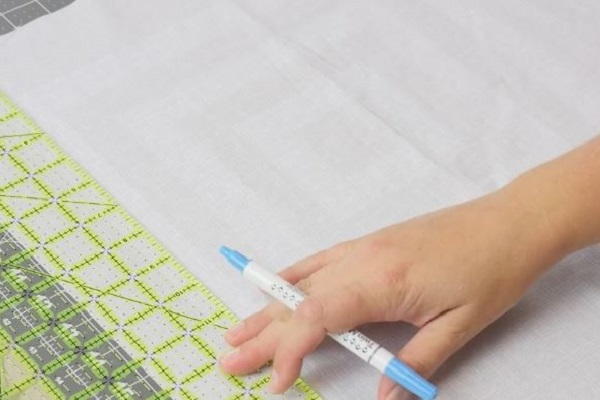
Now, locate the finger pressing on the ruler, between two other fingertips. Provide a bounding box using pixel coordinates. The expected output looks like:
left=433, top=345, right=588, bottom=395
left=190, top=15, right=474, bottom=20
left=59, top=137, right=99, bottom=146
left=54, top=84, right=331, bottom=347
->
left=219, top=324, right=282, bottom=375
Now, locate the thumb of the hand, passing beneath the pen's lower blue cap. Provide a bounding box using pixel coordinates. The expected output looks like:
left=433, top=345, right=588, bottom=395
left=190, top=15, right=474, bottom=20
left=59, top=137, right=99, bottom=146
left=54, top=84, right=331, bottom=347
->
left=377, top=306, right=479, bottom=400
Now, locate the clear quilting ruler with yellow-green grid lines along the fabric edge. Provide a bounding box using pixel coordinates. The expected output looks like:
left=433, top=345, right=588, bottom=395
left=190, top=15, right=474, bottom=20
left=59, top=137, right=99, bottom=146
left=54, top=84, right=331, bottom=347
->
left=0, top=93, right=320, bottom=400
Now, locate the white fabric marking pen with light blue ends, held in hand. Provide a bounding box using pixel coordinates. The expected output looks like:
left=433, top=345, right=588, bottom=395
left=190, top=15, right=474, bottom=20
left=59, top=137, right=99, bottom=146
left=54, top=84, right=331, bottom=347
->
left=219, top=246, right=437, bottom=400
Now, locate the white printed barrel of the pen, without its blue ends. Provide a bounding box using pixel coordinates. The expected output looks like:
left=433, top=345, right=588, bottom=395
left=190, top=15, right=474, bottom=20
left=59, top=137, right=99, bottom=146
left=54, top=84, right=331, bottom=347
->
left=243, top=261, right=393, bottom=372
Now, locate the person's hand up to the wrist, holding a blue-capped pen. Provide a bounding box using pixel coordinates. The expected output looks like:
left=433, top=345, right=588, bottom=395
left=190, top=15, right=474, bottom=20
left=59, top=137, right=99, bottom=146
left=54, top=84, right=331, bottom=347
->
left=221, top=182, right=562, bottom=399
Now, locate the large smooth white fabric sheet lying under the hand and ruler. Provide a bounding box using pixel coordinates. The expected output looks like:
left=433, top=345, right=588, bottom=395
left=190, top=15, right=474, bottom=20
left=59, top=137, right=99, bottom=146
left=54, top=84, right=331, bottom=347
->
left=0, top=0, right=600, bottom=400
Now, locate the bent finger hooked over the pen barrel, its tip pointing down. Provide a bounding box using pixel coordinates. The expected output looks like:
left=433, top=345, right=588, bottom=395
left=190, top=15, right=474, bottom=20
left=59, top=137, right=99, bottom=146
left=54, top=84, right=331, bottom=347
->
left=269, top=299, right=327, bottom=393
